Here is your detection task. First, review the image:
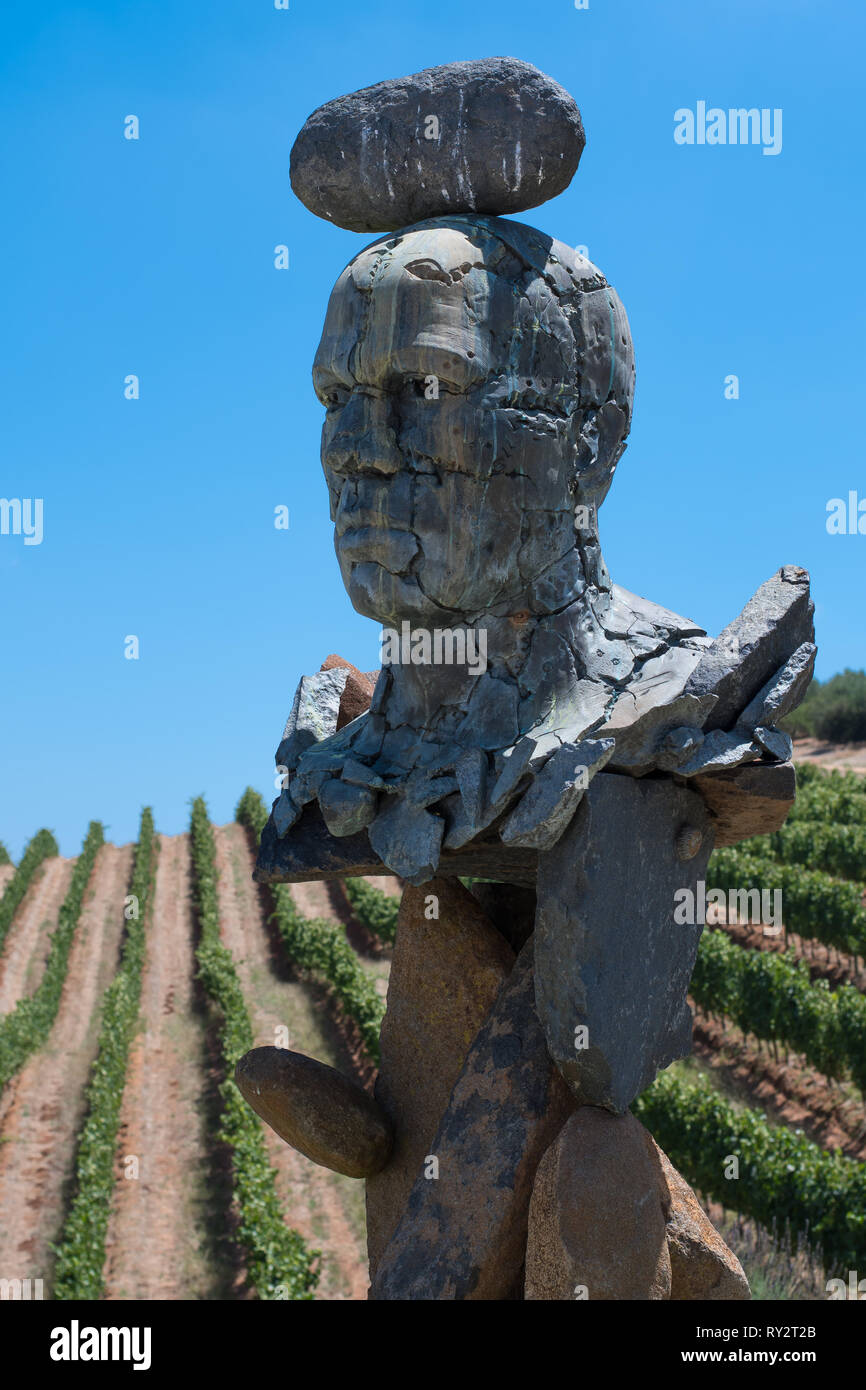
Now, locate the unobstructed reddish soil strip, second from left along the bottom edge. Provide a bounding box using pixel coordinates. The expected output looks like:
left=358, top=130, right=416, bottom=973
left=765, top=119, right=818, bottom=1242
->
left=106, top=835, right=228, bottom=1300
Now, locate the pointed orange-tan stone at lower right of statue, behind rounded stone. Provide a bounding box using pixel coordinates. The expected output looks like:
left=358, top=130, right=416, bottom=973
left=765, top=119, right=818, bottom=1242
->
left=652, top=1141, right=751, bottom=1302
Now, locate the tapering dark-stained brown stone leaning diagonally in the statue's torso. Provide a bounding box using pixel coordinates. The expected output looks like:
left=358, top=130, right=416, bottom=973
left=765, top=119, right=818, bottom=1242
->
left=370, top=941, right=573, bottom=1301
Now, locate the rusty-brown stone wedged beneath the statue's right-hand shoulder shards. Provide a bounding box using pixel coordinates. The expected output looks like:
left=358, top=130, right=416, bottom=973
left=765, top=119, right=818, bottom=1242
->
left=689, top=763, right=796, bottom=847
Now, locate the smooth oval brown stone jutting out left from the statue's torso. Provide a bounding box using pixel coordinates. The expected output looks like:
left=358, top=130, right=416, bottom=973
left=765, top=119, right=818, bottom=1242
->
left=235, top=1047, right=392, bottom=1177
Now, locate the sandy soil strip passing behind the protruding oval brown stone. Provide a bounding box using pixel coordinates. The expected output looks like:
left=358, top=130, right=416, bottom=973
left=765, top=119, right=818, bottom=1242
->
left=214, top=824, right=368, bottom=1300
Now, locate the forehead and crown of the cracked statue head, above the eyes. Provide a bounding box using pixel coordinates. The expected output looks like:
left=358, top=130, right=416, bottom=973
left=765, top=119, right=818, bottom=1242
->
left=313, top=218, right=634, bottom=413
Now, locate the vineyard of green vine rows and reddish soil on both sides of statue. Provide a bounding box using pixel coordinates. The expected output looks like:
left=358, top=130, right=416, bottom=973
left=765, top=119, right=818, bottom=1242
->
left=0, top=765, right=866, bottom=1301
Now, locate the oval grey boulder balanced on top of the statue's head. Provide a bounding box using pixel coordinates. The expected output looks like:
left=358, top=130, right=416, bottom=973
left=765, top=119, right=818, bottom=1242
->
left=291, top=58, right=585, bottom=232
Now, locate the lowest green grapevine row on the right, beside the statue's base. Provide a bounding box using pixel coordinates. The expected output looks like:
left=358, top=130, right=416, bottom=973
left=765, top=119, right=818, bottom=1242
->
left=632, top=1072, right=866, bottom=1272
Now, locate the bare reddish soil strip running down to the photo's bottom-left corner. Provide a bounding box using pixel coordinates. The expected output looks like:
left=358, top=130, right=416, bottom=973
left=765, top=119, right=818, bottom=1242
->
left=0, top=845, right=132, bottom=1284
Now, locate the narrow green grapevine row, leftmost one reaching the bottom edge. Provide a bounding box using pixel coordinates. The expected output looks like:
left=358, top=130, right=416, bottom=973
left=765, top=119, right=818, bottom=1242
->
left=54, top=806, right=156, bottom=1300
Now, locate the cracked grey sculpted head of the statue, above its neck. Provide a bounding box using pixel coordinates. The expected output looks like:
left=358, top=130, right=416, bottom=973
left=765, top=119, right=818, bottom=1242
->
left=313, top=217, right=634, bottom=626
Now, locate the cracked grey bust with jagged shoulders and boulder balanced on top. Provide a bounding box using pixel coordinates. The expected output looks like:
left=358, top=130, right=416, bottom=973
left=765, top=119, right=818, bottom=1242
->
left=262, top=58, right=815, bottom=883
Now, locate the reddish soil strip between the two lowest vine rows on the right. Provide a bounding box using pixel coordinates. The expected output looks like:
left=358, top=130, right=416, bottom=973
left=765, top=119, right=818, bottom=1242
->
left=689, top=1001, right=866, bottom=1162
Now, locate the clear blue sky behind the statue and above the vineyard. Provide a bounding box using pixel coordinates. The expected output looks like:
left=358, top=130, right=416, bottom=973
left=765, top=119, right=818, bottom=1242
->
left=0, top=0, right=866, bottom=856
